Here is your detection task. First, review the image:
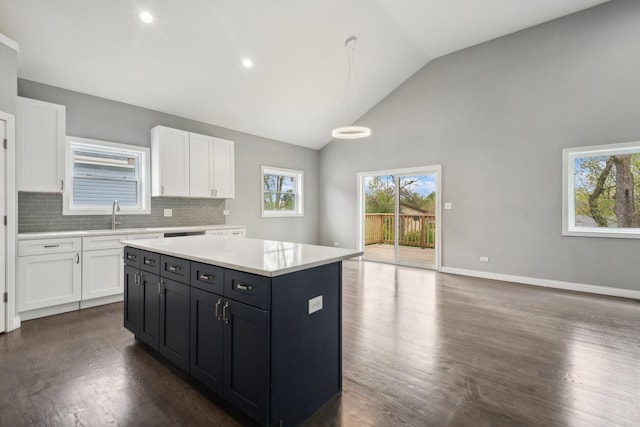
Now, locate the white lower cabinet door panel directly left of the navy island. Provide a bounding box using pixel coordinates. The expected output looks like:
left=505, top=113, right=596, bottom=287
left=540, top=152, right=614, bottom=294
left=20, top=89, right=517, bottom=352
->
left=82, top=249, right=124, bottom=300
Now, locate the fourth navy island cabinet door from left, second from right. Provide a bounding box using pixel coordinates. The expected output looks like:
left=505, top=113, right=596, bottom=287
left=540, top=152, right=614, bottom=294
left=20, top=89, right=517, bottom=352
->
left=189, top=288, right=224, bottom=395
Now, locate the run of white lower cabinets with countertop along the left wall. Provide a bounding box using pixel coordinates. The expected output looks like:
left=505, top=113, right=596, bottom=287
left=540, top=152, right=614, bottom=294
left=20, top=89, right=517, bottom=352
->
left=16, top=227, right=245, bottom=320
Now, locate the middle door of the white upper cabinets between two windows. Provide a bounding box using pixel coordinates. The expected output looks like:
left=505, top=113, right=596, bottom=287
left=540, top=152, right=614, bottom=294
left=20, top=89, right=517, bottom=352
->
left=189, top=133, right=213, bottom=197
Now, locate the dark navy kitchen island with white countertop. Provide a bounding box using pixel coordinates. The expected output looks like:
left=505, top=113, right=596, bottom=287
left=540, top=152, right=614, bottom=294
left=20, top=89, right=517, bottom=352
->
left=124, top=236, right=360, bottom=426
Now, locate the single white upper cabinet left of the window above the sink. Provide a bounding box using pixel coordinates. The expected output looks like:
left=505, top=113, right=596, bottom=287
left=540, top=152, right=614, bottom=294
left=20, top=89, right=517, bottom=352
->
left=16, top=97, right=67, bottom=193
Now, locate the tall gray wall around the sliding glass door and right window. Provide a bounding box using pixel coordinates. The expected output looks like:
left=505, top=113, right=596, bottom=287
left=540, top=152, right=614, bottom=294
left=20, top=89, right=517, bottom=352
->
left=320, top=0, right=640, bottom=290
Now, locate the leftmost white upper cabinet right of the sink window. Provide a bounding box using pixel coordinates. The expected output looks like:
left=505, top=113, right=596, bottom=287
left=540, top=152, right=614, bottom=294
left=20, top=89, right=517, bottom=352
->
left=151, top=126, right=189, bottom=197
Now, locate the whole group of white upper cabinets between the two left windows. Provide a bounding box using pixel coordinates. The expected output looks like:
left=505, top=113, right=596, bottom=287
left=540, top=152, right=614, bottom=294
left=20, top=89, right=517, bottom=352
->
left=151, top=126, right=235, bottom=199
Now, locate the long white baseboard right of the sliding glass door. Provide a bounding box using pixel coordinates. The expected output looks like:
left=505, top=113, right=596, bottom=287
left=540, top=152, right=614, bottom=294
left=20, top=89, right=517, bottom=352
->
left=442, top=267, right=640, bottom=300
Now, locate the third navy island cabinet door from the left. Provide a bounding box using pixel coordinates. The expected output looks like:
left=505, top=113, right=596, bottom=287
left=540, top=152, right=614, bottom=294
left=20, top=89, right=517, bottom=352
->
left=159, top=278, right=191, bottom=372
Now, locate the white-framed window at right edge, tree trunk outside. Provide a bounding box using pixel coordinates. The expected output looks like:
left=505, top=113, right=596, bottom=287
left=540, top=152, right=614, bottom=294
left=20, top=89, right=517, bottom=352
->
left=562, top=142, right=640, bottom=238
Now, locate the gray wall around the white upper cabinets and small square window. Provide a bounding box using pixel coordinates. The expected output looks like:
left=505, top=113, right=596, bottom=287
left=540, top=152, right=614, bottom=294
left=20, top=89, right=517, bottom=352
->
left=18, top=79, right=319, bottom=243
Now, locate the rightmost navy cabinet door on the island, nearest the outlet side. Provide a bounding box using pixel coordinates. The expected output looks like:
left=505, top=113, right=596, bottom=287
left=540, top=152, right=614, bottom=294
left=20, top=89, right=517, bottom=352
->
left=223, top=300, right=270, bottom=425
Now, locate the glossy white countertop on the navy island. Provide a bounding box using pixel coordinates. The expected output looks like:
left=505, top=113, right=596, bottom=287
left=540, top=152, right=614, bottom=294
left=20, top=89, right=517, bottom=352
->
left=123, top=235, right=362, bottom=277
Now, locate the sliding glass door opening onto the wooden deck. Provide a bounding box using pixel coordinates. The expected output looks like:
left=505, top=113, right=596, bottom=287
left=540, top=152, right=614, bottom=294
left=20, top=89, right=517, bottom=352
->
left=358, top=166, right=440, bottom=269
